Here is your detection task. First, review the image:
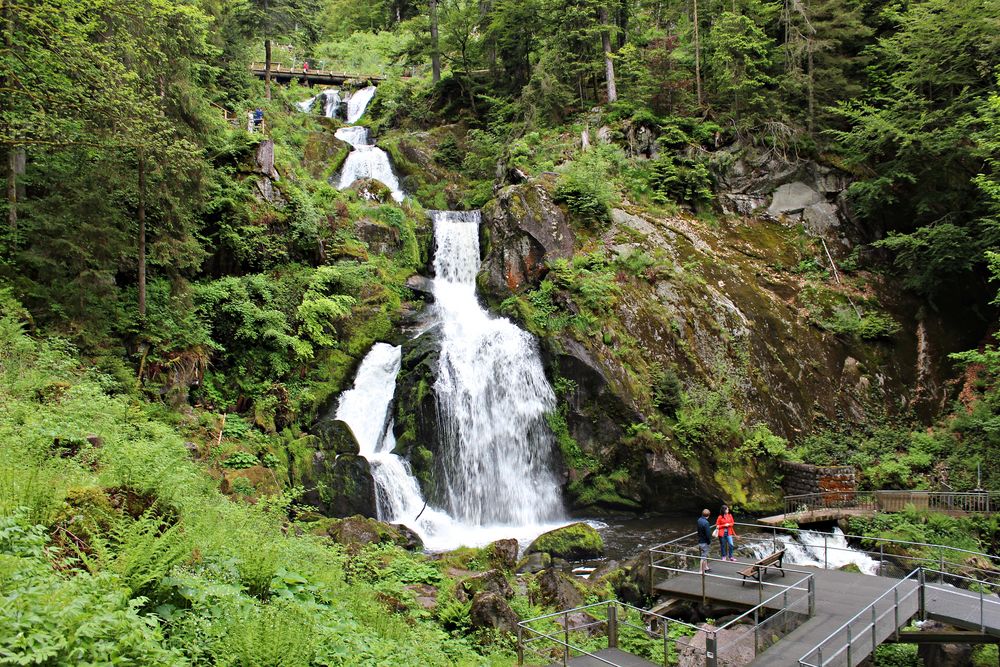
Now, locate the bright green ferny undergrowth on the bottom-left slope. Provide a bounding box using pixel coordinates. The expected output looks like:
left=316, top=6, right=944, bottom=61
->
left=0, top=309, right=512, bottom=665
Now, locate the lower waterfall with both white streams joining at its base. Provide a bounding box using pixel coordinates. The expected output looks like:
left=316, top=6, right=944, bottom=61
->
left=336, top=211, right=566, bottom=551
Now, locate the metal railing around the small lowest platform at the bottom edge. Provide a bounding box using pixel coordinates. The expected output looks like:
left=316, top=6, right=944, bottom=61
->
left=517, top=600, right=706, bottom=667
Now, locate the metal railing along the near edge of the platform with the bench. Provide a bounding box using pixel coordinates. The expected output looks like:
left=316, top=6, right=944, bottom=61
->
left=649, top=546, right=816, bottom=667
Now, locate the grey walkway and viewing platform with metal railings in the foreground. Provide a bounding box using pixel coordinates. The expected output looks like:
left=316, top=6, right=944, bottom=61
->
left=518, top=526, right=1000, bottom=667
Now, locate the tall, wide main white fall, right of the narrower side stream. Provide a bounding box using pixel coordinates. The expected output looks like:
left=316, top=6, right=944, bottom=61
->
left=432, top=211, right=562, bottom=526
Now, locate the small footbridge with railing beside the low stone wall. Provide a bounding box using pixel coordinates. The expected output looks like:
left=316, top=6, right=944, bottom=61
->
left=759, top=490, right=1000, bottom=526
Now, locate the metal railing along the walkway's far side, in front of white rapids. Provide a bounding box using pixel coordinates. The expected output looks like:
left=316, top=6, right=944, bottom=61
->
left=650, top=523, right=1000, bottom=585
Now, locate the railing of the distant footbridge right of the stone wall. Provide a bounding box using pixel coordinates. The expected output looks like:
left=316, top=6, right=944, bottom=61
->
left=785, top=490, right=1000, bottom=515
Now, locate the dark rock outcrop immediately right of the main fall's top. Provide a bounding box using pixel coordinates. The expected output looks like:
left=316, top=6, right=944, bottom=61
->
left=480, top=181, right=575, bottom=299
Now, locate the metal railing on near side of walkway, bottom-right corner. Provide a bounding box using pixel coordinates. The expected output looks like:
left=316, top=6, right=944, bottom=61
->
left=799, top=567, right=1000, bottom=667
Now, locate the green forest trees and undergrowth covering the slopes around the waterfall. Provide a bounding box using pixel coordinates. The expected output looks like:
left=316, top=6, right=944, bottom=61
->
left=0, top=0, right=1000, bottom=665
